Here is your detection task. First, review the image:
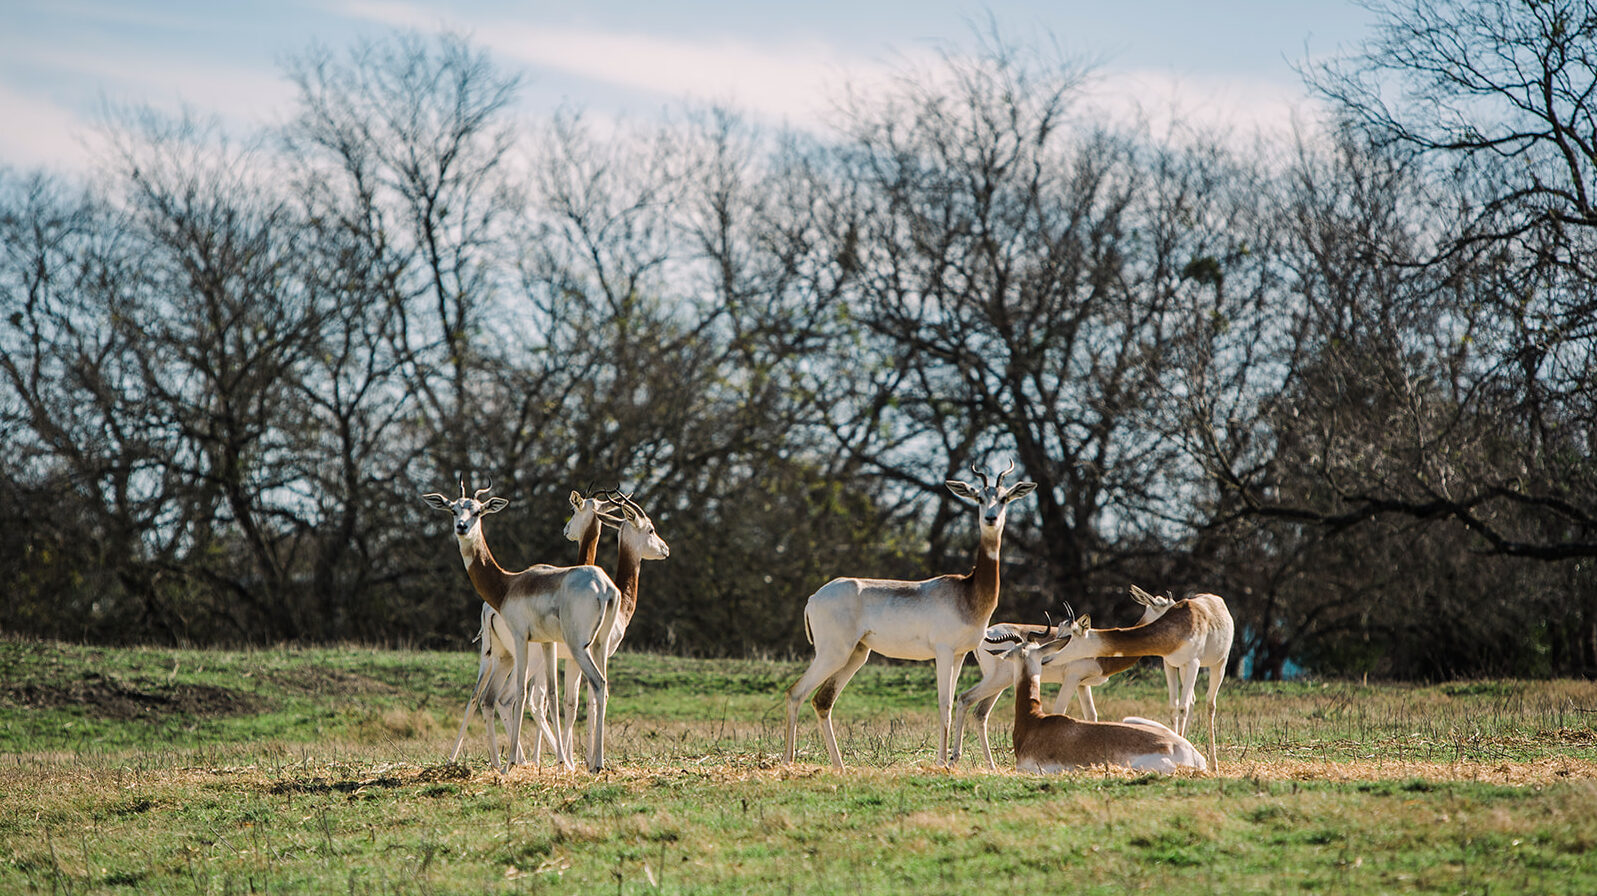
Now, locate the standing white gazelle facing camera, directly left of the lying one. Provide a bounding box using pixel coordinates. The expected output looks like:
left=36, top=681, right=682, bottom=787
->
left=783, top=462, right=1036, bottom=768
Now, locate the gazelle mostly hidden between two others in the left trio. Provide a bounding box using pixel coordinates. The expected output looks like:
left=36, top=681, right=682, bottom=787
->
left=449, top=490, right=613, bottom=765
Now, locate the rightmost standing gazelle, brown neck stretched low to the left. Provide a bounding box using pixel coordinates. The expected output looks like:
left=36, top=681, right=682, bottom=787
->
left=1054, top=589, right=1236, bottom=768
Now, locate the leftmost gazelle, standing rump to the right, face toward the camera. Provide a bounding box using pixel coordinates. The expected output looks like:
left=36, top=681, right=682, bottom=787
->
left=422, top=482, right=621, bottom=771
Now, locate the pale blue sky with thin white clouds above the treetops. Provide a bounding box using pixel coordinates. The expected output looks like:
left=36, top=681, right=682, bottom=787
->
left=0, top=0, right=1370, bottom=168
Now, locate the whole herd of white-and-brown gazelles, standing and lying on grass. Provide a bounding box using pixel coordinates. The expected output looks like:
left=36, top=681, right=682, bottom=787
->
left=423, top=463, right=1234, bottom=773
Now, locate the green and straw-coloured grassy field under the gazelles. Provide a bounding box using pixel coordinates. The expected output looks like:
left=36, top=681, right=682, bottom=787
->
left=0, top=640, right=1597, bottom=894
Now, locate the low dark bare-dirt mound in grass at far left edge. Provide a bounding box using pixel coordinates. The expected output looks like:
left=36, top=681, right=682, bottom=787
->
left=0, top=672, right=265, bottom=722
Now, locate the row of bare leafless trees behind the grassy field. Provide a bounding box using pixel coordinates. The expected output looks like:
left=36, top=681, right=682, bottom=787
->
left=0, top=3, right=1597, bottom=677
